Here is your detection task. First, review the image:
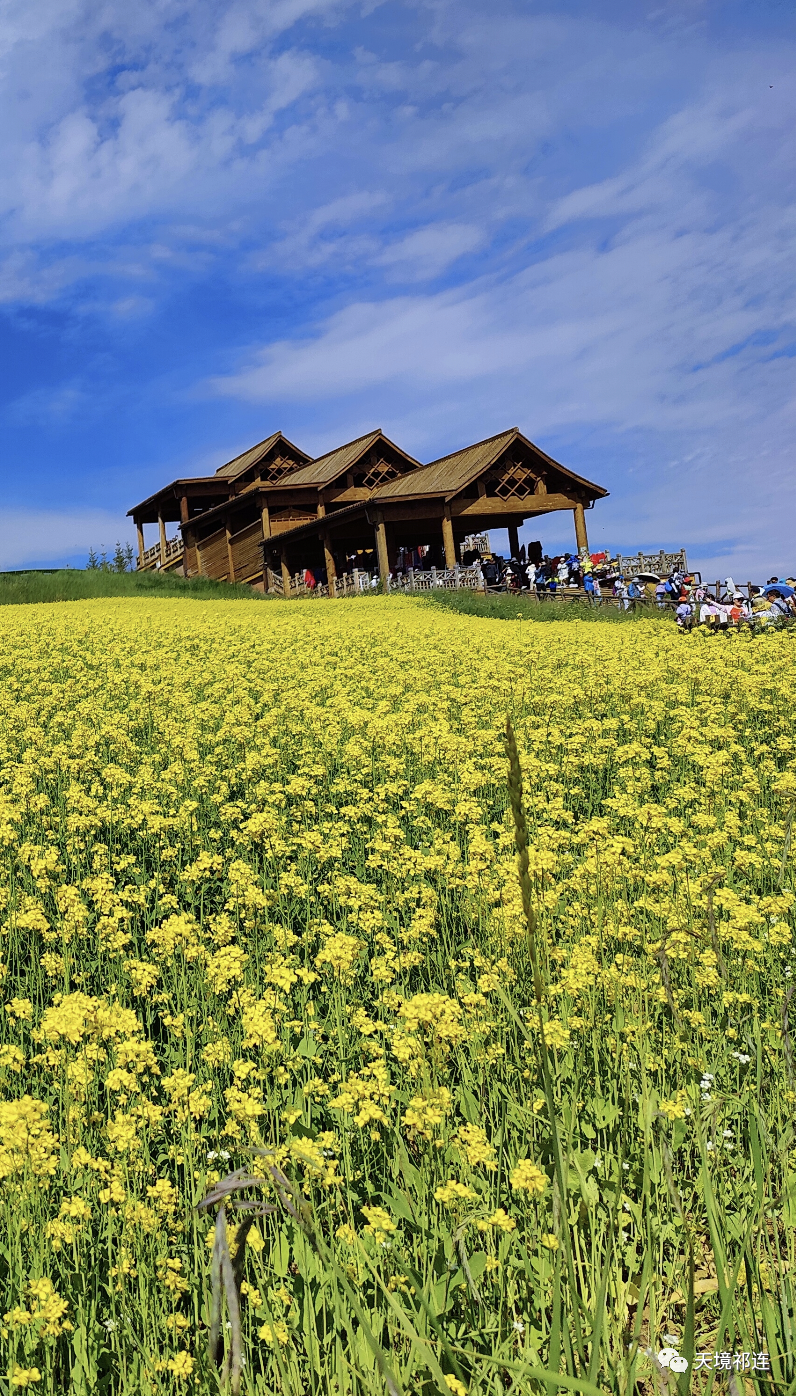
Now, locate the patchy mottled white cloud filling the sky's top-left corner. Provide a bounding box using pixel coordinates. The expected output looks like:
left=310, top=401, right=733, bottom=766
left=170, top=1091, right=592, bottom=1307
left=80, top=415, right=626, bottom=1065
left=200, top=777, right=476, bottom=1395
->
left=0, top=0, right=337, bottom=247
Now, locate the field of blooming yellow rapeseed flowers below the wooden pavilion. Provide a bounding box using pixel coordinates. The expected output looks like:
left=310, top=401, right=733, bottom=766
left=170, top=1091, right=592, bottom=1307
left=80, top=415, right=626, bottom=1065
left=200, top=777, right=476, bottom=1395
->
left=0, top=597, right=796, bottom=1396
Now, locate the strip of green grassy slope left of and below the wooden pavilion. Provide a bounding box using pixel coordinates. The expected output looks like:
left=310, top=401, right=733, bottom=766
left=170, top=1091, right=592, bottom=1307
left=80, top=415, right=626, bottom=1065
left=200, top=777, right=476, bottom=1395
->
left=0, top=570, right=264, bottom=606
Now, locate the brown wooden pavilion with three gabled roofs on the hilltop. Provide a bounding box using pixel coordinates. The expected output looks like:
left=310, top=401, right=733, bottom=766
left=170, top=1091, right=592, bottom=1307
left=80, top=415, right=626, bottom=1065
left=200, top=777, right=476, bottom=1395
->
left=130, top=427, right=607, bottom=595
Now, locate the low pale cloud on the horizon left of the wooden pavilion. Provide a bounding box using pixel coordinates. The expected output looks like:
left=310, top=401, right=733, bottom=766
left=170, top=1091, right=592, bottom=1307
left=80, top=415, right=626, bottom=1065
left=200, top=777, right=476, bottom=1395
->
left=0, top=508, right=134, bottom=571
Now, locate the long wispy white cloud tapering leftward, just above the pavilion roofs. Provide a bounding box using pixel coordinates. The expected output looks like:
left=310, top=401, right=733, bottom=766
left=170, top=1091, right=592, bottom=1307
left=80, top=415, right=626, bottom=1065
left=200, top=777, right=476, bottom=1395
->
left=212, top=208, right=796, bottom=430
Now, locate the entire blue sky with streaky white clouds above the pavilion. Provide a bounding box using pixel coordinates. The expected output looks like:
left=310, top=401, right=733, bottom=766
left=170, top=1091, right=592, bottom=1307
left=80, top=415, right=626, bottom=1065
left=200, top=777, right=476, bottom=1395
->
left=0, top=0, right=796, bottom=581
